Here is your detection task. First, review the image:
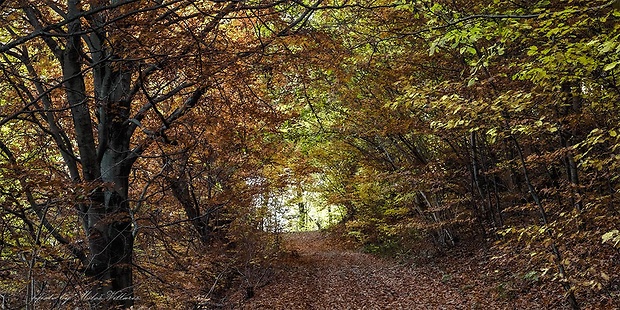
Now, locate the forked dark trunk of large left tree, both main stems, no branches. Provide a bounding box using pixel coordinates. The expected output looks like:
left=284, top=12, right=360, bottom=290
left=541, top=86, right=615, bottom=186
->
left=62, top=6, right=133, bottom=302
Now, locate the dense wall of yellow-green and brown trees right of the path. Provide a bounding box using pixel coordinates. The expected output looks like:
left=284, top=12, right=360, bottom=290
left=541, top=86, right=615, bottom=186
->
left=278, top=1, right=620, bottom=309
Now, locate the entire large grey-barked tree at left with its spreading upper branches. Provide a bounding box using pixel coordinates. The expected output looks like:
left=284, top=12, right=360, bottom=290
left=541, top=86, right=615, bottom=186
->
left=0, top=0, right=298, bottom=309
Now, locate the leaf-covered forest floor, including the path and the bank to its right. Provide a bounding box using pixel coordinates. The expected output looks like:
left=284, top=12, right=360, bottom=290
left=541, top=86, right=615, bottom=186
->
left=240, top=232, right=588, bottom=309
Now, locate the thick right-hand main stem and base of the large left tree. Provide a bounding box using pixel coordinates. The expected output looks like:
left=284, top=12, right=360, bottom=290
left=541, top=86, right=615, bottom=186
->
left=86, top=64, right=134, bottom=308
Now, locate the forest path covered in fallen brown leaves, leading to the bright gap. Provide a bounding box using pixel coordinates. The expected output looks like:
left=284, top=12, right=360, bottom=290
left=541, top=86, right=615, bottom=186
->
left=242, top=232, right=471, bottom=309
